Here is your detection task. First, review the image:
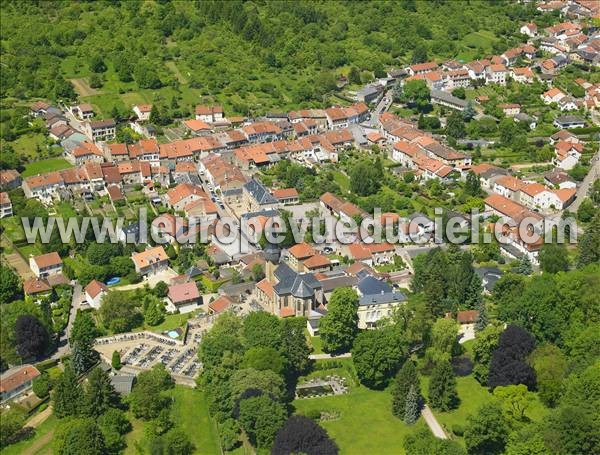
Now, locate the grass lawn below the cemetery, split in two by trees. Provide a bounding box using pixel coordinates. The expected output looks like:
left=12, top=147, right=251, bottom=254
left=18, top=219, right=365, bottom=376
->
left=124, top=385, right=221, bottom=455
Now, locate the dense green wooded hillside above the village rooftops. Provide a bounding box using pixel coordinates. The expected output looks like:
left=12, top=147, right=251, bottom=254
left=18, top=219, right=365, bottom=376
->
left=0, top=0, right=550, bottom=121
